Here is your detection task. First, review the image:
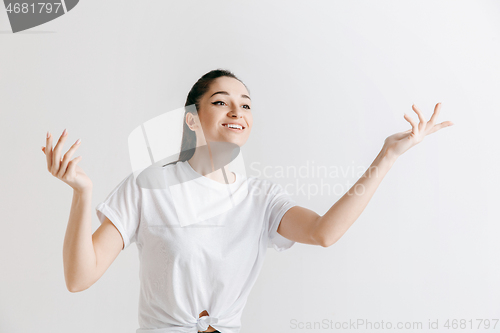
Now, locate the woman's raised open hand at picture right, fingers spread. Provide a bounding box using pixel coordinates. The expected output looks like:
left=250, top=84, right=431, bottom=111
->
left=383, top=103, right=453, bottom=157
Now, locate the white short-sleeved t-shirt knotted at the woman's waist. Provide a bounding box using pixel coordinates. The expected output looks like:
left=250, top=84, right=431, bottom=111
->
left=96, top=161, right=296, bottom=333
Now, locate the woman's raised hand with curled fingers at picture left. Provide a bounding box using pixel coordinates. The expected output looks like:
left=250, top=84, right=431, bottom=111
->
left=42, top=130, right=92, bottom=191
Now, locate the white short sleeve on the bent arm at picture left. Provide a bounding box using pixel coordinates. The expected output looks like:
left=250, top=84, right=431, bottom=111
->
left=96, top=173, right=142, bottom=251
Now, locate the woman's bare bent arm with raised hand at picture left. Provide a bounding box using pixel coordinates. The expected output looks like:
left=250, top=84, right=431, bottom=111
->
left=42, top=130, right=124, bottom=292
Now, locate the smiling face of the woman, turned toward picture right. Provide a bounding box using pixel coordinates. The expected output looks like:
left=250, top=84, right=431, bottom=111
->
left=186, top=76, right=253, bottom=147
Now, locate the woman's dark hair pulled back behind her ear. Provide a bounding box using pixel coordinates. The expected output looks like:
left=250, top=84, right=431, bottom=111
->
left=164, top=68, right=250, bottom=166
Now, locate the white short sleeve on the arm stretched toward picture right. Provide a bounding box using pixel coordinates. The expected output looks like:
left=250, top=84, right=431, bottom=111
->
left=266, top=183, right=297, bottom=252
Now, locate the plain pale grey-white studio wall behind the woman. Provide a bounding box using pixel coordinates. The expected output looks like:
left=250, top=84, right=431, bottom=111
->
left=0, top=0, right=500, bottom=333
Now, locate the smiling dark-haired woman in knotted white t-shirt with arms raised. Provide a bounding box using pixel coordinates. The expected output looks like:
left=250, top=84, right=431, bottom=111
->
left=42, top=69, right=452, bottom=333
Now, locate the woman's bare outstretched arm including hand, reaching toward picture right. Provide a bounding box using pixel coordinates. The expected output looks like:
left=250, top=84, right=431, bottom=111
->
left=278, top=103, right=453, bottom=247
